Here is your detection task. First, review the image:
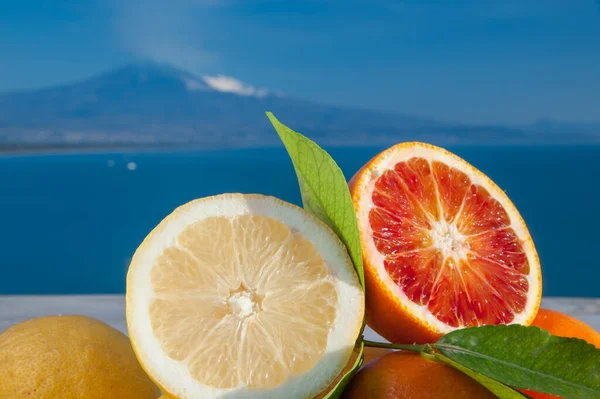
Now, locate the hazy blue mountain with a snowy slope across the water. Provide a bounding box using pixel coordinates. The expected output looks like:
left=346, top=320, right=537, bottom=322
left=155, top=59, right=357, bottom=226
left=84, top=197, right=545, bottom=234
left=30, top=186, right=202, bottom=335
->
left=0, top=64, right=600, bottom=149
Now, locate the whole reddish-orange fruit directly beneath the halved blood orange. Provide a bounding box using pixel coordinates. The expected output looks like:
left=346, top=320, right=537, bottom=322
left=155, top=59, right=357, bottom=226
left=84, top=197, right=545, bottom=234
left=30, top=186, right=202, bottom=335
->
left=342, top=351, right=496, bottom=399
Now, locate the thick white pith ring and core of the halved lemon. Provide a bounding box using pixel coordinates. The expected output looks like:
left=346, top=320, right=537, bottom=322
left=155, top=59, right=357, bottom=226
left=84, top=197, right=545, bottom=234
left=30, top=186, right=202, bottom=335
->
left=127, top=194, right=364, bottom=399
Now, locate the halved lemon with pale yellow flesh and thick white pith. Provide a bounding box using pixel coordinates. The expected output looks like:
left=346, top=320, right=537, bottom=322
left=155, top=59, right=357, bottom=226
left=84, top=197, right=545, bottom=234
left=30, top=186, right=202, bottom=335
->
left=126, top=194, right=364, bottom=398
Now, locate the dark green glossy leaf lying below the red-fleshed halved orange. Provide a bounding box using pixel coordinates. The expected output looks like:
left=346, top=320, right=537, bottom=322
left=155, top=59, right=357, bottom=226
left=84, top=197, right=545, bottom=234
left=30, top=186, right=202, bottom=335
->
left=433, top=324, right=600, bottom=399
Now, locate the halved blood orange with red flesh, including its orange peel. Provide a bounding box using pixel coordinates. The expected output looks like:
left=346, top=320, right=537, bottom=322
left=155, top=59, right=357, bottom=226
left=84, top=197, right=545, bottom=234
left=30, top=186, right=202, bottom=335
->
left=350, top=143, right=542, bottom=343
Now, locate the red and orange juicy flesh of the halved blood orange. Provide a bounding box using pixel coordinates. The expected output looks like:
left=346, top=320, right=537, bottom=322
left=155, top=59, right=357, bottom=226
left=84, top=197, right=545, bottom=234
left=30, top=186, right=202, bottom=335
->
left=369, top=158, right=529, bottom=327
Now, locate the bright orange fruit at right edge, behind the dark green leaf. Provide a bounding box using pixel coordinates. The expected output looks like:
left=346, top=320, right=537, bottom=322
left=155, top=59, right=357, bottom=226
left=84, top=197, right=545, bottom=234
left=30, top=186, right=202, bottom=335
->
left=523, top=308, right=600, bottom=399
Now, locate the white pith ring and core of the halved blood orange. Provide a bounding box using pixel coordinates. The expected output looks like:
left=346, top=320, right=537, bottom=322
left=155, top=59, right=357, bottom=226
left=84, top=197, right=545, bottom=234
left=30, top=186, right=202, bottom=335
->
left=355, top=143, right=541, bottom=333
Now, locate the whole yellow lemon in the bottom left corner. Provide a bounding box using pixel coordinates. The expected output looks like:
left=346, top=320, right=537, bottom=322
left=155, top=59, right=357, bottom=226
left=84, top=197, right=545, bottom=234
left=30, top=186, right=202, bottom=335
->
left=0, top=316, right=160, bottom=399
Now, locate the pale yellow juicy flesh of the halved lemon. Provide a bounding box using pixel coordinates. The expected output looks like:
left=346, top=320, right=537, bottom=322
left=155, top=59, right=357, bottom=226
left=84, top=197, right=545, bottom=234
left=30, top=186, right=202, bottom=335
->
left=150, top=215, right=337, bottom=389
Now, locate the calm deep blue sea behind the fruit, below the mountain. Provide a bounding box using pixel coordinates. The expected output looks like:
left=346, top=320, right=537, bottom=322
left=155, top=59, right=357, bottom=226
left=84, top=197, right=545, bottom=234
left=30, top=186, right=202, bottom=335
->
left=0, top=147, right=600, bottom=297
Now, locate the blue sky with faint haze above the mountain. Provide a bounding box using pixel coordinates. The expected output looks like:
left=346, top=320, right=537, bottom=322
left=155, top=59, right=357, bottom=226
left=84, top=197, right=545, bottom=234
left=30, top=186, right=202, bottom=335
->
left=0, top=0, right=600, bottom=123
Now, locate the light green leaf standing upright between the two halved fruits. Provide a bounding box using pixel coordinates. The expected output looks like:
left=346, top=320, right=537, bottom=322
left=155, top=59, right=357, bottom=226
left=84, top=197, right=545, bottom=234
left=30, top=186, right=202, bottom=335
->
left=267, top=112, right=365, bottom=287
